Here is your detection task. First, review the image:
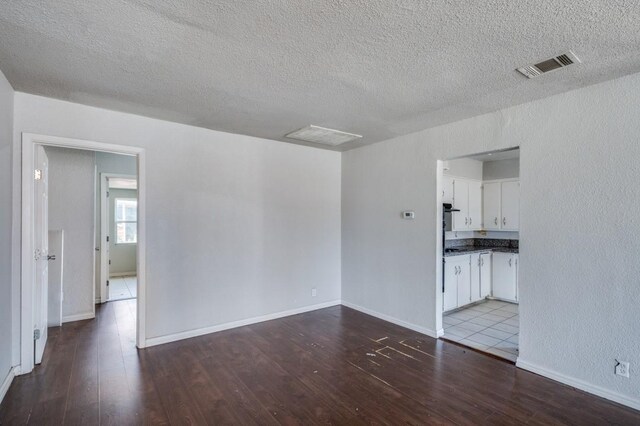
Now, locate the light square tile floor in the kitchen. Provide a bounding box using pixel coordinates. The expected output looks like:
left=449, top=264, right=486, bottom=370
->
left=442, top=300, right=520, bottom=361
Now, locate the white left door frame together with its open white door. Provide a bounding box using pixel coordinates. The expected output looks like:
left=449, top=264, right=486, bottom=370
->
left=20, top=133, right=146, bottom=374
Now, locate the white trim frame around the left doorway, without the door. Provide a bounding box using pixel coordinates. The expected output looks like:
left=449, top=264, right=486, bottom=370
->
left=19, top=133, right=146, bottom=374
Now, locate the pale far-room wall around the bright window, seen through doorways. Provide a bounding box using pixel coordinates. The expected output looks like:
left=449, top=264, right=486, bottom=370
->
left=109, top=188, right=138, bottom=276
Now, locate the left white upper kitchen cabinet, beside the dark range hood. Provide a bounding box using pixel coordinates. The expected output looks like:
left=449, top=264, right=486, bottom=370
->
left=445, top=178, right=482, bottom=231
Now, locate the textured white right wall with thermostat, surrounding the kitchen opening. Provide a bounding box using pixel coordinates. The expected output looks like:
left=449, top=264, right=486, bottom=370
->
left=342, top=74, right=640, bottom=408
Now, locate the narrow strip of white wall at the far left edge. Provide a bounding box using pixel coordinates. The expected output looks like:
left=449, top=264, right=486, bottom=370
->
left=0, top=72, right=14, bottom=385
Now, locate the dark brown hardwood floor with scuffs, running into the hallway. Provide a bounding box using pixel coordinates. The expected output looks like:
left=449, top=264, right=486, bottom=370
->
left=0, top=300, right=640, bottom=425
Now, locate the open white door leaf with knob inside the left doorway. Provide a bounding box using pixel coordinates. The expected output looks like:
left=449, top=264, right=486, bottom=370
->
left=33, top=145, right=49, bottom=364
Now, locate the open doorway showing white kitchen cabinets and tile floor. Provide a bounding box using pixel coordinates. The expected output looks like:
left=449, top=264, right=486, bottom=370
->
left=439, top=148, right=520, bottom=362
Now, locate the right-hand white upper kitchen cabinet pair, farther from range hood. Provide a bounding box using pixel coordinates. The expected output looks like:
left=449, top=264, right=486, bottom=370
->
left=482, top=181, right=520, bottom=231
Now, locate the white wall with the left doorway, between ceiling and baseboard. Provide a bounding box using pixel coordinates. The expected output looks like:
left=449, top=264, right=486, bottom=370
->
left=14, top=93, right=341, bottom=338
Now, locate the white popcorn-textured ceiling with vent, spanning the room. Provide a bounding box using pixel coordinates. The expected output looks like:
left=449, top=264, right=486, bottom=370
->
left=0, top=0, right=640, bottom=150
